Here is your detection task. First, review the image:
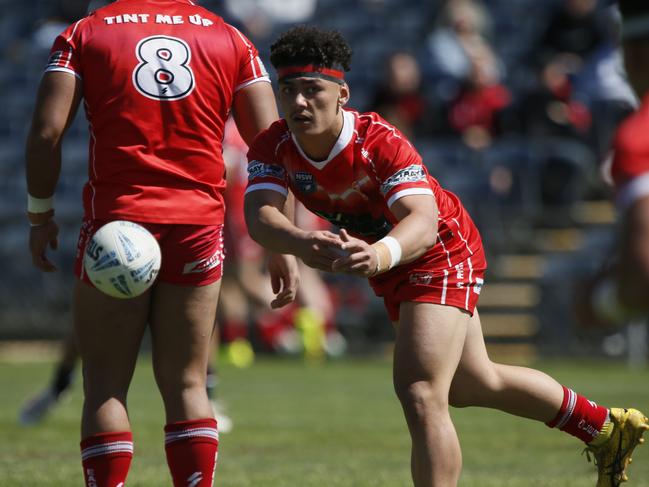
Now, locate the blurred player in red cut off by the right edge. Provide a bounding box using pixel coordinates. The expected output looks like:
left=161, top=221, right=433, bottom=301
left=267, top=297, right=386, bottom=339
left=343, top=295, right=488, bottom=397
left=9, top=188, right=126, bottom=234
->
left=586, top=1, right=649, bottom=327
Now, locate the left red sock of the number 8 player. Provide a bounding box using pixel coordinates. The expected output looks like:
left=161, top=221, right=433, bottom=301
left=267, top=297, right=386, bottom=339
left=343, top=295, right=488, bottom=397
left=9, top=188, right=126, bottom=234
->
left=81, top=431, right=133, bottom=487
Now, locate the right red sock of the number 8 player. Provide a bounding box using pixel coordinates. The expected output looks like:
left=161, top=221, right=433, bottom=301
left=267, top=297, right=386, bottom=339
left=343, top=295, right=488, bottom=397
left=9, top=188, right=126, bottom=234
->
left=165, top=418, right=219, bottom=487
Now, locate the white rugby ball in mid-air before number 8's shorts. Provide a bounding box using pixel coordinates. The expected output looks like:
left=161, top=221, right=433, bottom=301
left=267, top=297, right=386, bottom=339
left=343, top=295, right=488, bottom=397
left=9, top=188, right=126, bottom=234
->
left=83, top=220, right=161, bottom=299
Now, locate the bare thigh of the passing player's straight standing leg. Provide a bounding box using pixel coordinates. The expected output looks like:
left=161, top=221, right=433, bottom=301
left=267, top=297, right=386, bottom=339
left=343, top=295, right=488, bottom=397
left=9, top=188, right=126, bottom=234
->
left=394, top=302, right=469, bottom=392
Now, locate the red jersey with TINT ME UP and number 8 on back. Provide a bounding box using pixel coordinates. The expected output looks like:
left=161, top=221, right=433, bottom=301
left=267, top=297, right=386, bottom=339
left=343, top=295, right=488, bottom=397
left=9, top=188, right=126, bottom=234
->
left=46, top=0, right=269, bottom=225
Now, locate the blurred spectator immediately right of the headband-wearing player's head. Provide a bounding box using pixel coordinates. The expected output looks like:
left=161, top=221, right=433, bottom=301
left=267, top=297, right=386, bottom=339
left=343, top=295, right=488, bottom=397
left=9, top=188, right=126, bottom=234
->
left=368, top=51, right=428, bottom=138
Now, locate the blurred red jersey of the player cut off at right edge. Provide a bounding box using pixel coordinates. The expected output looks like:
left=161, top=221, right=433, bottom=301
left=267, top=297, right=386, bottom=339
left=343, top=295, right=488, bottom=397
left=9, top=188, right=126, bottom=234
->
left=611, top=96, right=649, bottom=208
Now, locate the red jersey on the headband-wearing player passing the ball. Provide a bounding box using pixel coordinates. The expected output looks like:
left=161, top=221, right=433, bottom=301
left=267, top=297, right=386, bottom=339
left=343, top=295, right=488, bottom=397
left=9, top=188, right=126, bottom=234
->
left=247, top=110, right=482, bottom=278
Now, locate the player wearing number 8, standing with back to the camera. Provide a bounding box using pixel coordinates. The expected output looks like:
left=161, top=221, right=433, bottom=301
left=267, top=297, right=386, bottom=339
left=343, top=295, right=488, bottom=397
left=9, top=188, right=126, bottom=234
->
left=26, top=0, right=297, bottom=487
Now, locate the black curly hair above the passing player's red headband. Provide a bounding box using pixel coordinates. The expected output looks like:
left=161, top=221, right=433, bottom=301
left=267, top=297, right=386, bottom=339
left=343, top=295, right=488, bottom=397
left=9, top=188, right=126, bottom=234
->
left=270, top=26, right=352, bottom=71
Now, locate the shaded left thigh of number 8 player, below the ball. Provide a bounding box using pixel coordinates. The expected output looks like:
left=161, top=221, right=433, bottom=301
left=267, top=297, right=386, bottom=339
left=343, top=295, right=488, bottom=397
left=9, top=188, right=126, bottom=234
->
left=74, top=279, right=151, bottom=387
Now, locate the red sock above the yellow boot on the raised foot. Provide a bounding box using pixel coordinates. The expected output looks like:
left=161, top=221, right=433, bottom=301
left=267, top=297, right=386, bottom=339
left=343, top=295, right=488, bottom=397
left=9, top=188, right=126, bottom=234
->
left=546, top=387, right=608, bottom=443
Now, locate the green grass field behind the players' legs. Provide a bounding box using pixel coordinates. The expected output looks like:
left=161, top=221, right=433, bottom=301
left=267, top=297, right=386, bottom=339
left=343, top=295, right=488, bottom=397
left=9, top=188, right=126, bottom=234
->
left=0, top=358, right=649, bottom=487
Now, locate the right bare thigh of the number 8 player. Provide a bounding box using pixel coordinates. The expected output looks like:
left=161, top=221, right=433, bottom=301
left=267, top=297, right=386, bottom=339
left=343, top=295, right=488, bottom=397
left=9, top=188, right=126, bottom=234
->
left=150, top=280, right=221, bottom=385
